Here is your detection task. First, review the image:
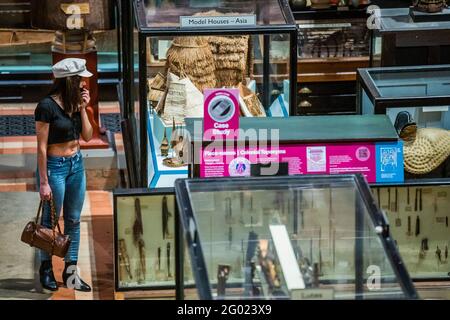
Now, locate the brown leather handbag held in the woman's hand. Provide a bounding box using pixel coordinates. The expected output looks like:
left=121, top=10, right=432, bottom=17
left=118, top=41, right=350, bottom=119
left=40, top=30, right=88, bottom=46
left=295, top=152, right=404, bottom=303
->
left=21, top=199, right=71, bottom=258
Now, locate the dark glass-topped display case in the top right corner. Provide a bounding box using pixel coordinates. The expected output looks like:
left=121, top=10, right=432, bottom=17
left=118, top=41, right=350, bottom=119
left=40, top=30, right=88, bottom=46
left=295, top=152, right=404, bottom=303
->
left=371, top=7, right=450, bottom=67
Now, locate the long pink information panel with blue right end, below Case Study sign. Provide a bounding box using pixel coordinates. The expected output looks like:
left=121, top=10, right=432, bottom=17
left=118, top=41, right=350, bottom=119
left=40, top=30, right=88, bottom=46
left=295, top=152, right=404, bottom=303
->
left=200, top=142, right=403, bottom=183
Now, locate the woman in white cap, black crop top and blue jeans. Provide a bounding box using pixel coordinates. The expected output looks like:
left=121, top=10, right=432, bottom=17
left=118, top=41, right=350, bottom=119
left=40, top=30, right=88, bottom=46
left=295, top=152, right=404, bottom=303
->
left=35, top=58, right=93, bottom=292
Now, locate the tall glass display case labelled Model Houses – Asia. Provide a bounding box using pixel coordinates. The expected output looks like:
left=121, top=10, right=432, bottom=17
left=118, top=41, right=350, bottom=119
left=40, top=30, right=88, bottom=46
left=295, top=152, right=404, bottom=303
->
left=128, top=0, right=297, bottom=187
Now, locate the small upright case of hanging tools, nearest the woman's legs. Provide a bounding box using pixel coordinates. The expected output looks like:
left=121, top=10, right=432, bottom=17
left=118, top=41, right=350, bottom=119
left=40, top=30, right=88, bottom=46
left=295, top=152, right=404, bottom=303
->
left=114, top=189, right=176, bottom=297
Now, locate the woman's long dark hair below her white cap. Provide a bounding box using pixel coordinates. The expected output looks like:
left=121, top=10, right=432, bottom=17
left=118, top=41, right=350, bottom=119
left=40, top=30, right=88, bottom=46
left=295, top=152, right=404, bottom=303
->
left=49, top=76, right=82, bottom=114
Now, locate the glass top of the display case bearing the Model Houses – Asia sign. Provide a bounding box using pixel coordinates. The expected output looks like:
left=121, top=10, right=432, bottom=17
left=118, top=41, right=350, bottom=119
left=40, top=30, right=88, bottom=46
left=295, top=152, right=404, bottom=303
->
left=134, top=0, right=295, bottom=33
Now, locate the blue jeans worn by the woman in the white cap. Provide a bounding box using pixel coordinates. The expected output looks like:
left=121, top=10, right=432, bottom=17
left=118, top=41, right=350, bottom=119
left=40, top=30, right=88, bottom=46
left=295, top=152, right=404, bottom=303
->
left=37, top=151, right=86, bottom=262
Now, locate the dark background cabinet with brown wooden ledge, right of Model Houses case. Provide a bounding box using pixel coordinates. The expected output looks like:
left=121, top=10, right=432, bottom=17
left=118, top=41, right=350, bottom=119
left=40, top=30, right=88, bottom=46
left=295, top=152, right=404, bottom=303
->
left=291, top=1, right=371, bottom=115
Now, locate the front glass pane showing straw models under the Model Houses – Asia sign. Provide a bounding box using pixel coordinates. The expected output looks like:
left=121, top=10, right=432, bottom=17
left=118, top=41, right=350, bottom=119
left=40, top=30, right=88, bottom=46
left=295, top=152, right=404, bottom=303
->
left=146, top=32, right=291, bottom=117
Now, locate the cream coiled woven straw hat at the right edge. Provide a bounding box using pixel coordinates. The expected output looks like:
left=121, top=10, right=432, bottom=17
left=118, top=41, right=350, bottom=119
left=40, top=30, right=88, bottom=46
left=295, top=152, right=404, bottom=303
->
left=403, top=128, right=450, bottom=174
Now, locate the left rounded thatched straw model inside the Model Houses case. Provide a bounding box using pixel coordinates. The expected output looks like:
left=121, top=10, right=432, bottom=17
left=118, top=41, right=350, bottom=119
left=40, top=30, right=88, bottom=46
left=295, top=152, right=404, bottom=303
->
left=166, top=37, right=216, bottom=92
